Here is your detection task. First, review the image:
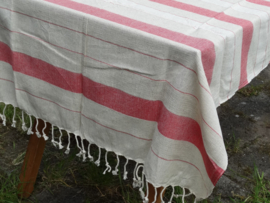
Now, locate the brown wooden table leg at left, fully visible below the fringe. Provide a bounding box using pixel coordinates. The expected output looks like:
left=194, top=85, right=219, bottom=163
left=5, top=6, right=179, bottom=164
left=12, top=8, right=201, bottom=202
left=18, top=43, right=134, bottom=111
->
left=18, top=119, right=51, bottom=198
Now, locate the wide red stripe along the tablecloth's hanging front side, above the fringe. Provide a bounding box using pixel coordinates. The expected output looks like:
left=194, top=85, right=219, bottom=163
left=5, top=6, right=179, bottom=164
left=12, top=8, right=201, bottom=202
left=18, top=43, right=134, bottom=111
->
left=0, top=42, right=224, bottom=185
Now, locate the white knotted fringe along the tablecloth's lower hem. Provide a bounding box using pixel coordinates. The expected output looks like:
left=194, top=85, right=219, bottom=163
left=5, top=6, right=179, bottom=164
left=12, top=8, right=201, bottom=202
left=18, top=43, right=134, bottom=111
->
left=0, top=102, right=198, bottom=203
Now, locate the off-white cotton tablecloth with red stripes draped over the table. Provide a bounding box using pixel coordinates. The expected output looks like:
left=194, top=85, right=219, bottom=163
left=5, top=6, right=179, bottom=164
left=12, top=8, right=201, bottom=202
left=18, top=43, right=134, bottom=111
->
left=0, top=0, right=270, bottom=202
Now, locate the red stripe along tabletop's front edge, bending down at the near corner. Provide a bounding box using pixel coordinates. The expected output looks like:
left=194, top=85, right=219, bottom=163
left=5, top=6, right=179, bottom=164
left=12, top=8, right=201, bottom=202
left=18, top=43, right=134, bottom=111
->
left=45, top=0, right=216, bottom=85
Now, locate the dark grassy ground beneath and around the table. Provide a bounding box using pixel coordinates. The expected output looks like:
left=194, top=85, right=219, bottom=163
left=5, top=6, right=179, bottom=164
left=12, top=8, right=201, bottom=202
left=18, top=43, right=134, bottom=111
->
left=0, top=67, right=270, bottom=203
